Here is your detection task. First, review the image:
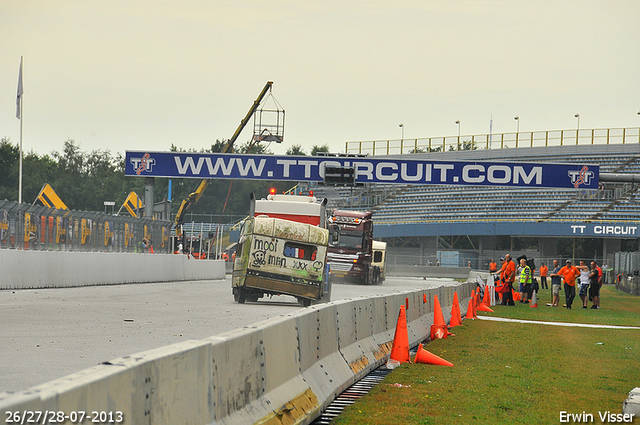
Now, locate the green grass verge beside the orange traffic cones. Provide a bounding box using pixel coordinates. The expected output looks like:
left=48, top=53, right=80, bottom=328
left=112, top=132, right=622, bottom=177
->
left=334, top=287, right=640, bottom=425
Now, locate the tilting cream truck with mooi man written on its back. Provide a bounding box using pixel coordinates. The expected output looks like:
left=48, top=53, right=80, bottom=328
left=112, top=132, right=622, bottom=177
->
left=231, top=194, right=331, bottom=307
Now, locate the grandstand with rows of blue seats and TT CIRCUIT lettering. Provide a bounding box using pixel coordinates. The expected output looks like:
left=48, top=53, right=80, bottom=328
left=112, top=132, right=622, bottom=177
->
left=304, top=142, right=640, bottom=268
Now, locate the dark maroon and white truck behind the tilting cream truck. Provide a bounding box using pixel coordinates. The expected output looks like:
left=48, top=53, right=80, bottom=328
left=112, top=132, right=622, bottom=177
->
left=327, top=210, right=384, bottom=285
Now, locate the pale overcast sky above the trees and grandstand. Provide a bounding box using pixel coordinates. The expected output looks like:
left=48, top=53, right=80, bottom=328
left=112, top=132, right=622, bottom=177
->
left=0, top=0, right=640, bottom=154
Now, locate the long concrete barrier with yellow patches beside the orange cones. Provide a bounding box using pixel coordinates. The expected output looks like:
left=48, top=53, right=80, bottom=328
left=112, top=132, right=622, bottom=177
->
left=0, top=282, right=475, bottom=425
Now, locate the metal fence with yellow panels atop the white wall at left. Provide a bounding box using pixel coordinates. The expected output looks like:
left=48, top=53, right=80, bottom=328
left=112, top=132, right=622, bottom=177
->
left=0, top=200, right=171, bottom=253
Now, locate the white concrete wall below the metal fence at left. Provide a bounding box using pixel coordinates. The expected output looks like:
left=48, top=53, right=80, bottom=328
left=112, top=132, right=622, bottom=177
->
left=0, top=249, right=225, bottom=289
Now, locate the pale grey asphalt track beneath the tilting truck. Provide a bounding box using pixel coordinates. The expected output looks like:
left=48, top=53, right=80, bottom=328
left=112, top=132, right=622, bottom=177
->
left=0, top=277, right=457, bottom=392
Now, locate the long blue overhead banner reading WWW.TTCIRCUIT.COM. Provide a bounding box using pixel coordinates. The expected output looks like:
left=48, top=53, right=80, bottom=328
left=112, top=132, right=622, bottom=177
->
left=125, top=151, right=599, bottom=189
